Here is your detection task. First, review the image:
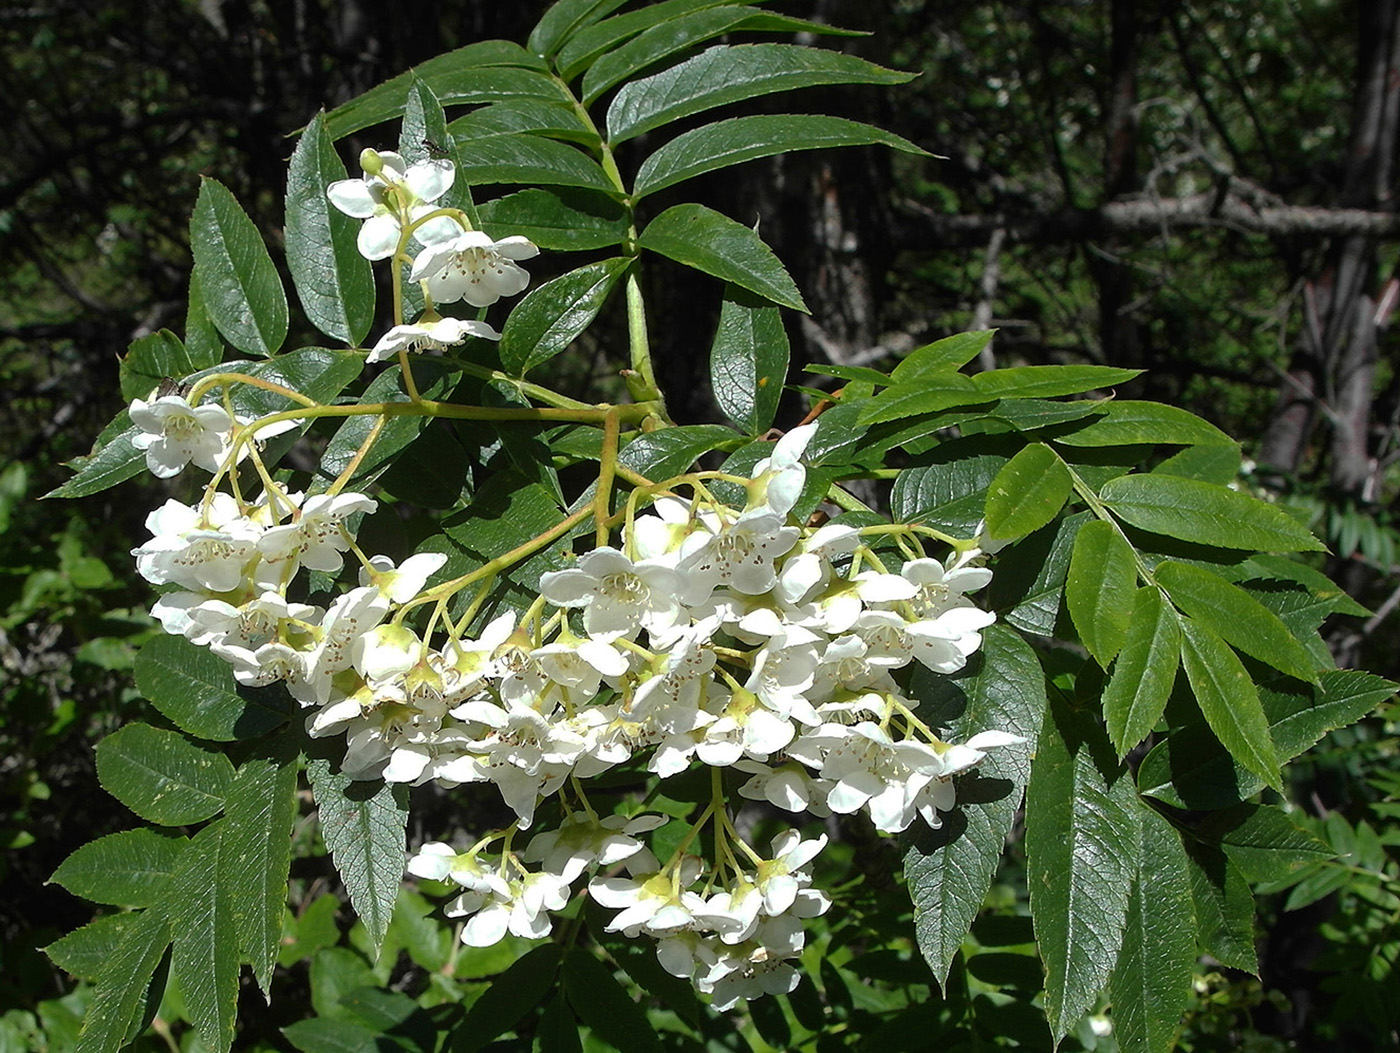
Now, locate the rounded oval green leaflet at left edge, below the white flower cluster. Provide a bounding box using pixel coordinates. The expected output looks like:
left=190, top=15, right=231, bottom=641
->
left=97, top=724, right=234, bottom=826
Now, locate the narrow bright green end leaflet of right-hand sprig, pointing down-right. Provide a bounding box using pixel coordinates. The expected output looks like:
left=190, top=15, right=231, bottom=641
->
left=1182, top=619, right=1282, bottom=791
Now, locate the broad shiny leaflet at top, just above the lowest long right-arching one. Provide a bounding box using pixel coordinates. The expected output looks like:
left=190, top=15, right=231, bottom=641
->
left=608, top=43, right=914, bottom=144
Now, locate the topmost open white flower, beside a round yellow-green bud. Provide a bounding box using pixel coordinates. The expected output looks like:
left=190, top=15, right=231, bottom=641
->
left=326, top=150, right=461, bottom=259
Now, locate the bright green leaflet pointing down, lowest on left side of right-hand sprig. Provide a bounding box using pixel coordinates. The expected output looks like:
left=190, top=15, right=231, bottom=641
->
left=1103, top=587, right=1182, bottom=756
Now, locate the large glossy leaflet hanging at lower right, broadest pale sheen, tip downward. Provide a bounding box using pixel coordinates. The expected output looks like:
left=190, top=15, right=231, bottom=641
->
left=1026, top=691, right=1142, bottom=1042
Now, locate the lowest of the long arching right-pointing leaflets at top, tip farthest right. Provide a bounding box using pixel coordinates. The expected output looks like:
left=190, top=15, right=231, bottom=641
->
left=633, top=113, right=927, bottom=200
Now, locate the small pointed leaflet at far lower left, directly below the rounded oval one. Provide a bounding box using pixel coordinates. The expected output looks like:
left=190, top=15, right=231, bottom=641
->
left=49, top=829, right=188, bottom=907
